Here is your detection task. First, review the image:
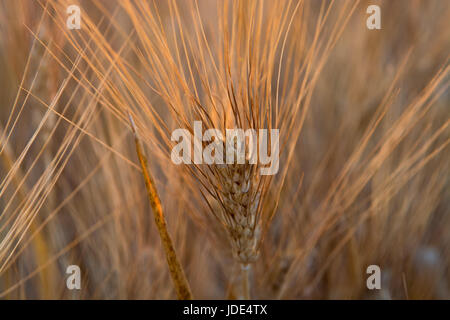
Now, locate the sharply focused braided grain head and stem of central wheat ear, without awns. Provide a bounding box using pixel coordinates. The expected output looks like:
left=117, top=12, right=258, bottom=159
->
left=207, top=132, right=264, bottom=299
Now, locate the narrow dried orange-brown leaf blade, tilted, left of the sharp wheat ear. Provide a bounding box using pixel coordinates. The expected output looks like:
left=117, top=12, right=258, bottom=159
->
left=128, top=113, right=193, bottom=300
